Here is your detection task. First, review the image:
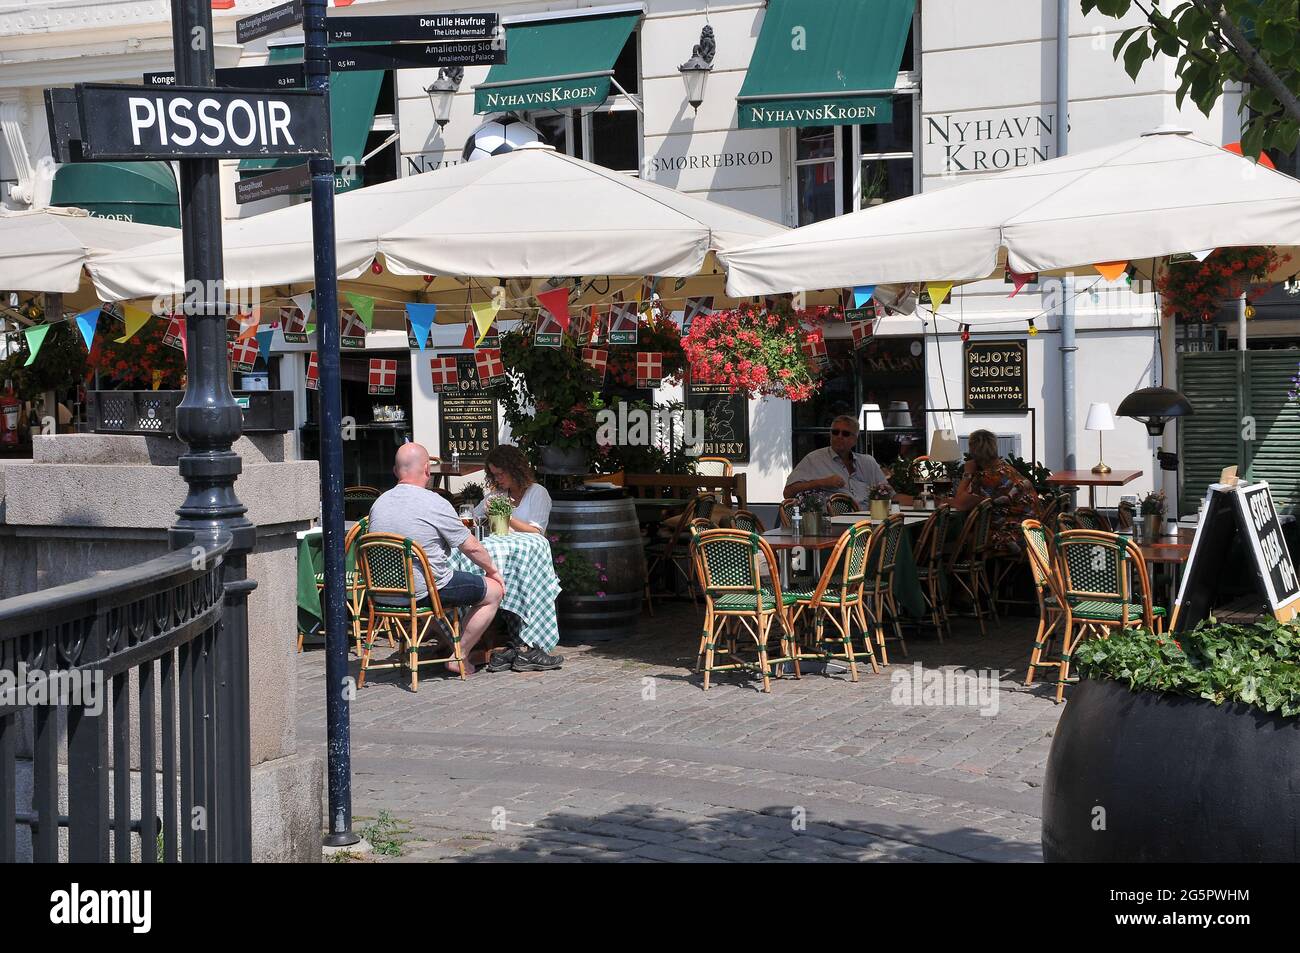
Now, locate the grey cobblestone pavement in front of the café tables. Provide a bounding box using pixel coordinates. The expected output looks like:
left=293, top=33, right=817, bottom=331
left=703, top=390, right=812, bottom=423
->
left=298, top=602, right=1061, bottom=862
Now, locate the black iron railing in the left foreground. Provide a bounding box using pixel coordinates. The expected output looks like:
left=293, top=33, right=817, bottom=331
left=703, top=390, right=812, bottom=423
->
left=0, top=540, right=251, bottom=863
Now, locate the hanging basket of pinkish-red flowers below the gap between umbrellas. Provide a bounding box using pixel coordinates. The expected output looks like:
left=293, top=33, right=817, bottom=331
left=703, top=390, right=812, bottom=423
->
left=683, top=304, right=832, bottom=402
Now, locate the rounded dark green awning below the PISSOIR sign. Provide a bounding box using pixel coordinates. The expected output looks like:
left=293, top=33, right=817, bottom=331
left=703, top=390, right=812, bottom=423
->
left=49, top=163, right=181, bottom=229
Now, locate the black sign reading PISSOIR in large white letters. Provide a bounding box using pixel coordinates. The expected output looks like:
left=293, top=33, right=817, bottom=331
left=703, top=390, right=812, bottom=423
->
left=77, top=83, right=329, bottom=160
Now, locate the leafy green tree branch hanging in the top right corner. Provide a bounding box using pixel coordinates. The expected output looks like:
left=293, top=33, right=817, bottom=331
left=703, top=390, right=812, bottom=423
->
left=1082, top=0, right=1300, bottom=157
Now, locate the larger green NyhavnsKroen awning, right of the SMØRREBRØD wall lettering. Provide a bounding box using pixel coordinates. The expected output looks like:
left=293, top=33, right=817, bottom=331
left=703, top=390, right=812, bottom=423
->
left=736, top=0, right=917, bottom=129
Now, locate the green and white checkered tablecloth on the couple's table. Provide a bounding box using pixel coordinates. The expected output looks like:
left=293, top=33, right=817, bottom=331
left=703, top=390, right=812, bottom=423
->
left=451, top=533, right=560, bottom=651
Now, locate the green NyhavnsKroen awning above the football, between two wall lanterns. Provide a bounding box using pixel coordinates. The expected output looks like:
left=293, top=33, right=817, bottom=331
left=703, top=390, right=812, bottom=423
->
left=475, top=10, right=641, bottom=113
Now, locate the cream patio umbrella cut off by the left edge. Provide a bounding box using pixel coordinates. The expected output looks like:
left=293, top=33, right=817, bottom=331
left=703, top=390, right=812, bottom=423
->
left=0, top=208, right=179, bottom=294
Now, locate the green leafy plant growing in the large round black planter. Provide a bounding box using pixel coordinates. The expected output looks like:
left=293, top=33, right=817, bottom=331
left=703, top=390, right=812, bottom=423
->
left=1074, top=618, right=1300, bottom=718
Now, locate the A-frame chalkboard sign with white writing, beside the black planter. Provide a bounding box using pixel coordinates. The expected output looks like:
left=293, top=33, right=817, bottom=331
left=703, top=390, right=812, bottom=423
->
left=1171, top=482, right=1300, bottom=632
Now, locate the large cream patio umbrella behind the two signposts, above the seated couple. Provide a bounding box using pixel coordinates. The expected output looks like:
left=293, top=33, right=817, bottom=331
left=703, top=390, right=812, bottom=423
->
left=91, top=147, right=787, bottom=300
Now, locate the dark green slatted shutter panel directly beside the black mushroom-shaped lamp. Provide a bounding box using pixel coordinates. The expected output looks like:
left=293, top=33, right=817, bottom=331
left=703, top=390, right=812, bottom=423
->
left=1178, top=351, right=1245, bottom=515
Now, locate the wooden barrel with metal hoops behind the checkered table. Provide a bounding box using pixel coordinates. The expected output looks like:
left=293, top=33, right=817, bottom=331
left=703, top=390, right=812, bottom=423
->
left=546, top=490, right=646, bottom=644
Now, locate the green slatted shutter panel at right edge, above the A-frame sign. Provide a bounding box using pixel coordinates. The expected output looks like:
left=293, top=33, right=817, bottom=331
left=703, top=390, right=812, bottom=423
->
left=1237, top=351, right=1300, bottom=508
